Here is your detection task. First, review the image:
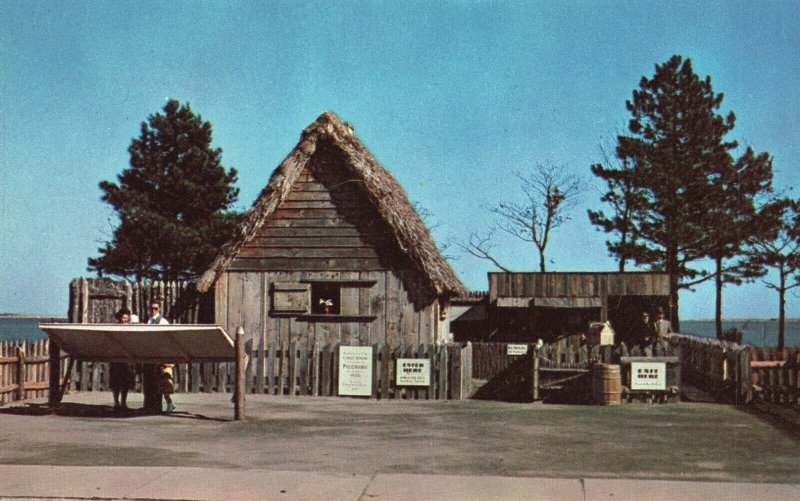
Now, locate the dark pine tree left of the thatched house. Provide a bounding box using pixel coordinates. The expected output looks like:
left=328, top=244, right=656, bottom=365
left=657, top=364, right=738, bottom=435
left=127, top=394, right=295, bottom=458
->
left=89, top=100, right=239, bottom=280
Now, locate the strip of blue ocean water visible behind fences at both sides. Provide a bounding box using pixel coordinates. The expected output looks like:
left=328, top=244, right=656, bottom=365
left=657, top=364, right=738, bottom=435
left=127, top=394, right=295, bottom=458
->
left=0, top=317, right=800, bottom=346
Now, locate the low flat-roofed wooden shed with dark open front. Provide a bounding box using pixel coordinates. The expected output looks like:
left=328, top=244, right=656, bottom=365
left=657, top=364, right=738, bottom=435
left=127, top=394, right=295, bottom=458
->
left=488, top=272, right=670, bottom=342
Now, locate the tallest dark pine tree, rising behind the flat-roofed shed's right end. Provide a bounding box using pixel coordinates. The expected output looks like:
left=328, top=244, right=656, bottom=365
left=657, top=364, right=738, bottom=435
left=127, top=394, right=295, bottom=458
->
left=590, top=55, right=736, bottom=329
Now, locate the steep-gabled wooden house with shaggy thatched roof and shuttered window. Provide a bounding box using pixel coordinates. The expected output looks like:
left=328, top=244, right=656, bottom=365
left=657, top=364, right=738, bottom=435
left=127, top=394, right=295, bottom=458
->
left=198, top=112, right=466, bottom=346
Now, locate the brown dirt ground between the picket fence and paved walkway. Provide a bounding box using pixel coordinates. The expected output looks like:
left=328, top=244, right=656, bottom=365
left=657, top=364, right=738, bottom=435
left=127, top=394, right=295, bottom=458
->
left=0, top=392, right=800, bottom=483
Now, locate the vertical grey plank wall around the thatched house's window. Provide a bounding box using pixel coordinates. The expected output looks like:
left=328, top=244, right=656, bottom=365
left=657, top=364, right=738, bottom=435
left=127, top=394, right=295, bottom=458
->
left=215, top=271, right=441, bottom=349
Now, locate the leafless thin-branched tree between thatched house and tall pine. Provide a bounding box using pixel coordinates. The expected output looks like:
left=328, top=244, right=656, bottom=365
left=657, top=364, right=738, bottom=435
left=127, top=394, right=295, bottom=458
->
left=457, top=164, right=584, bottom=272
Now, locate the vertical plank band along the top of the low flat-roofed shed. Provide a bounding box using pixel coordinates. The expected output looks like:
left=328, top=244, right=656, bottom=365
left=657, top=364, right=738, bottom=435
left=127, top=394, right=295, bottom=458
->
left=489, top=272, right=669, bottom=301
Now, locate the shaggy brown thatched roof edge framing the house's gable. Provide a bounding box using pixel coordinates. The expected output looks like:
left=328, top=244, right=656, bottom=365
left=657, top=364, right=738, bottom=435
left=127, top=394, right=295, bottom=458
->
left=198, top=112, right=467, bottom=296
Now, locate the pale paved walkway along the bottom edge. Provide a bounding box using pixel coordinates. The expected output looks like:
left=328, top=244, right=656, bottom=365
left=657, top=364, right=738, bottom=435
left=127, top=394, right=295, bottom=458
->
left=0, top=465, right=800, bottom=501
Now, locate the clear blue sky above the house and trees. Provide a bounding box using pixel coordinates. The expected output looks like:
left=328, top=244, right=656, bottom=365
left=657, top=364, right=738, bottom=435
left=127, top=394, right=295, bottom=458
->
left=0, top=0, right=800, bottom=318
